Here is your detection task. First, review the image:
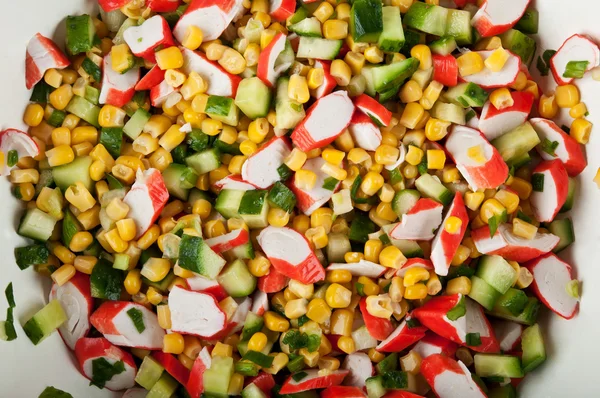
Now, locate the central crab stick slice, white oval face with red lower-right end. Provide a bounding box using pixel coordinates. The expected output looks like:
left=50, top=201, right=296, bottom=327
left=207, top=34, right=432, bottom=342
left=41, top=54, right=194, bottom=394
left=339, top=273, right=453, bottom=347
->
left=257, top=226, right=325, bottom=284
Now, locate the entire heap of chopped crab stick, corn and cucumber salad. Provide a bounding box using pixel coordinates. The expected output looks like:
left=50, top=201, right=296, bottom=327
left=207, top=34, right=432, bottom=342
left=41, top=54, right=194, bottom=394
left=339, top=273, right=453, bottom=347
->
left=5, top=0, right=600, bottom=398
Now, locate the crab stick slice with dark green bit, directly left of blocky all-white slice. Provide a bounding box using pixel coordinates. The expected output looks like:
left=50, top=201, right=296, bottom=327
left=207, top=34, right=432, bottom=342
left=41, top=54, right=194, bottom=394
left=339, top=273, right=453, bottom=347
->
left=90, top=301, right=165, bottom=350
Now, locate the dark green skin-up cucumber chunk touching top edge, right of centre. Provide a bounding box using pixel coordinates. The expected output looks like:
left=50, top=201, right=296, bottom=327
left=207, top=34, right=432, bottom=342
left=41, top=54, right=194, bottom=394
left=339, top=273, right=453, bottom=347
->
left=350, top=0, right=383, bottom=43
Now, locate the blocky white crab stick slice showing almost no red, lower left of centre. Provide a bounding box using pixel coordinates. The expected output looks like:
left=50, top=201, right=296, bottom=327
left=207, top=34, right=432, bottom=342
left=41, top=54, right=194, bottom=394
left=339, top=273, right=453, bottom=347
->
left=169, top=286, right=227, bottom=339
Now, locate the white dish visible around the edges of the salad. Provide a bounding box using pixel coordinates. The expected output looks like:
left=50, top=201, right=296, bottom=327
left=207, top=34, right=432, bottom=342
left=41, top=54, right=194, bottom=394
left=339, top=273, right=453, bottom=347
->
left=0, top=0, right=600, bottom=398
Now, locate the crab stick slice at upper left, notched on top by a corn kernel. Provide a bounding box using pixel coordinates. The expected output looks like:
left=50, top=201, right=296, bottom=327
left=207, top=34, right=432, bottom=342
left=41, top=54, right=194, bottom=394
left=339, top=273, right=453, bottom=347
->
left=98, top=54, right=140, bottom=108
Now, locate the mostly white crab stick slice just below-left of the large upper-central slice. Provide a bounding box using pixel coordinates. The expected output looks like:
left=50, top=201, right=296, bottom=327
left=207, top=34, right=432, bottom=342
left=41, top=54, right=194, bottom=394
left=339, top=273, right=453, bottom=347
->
left=242, top=137, right=292, bottom=189
